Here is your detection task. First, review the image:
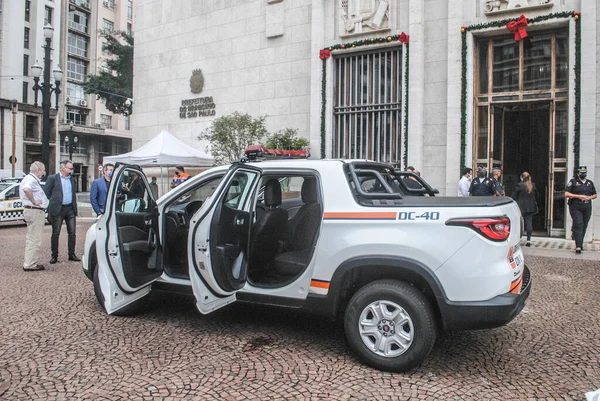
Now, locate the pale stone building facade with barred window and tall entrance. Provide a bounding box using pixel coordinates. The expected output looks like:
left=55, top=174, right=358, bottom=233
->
left=133, top=0, right=600, bottom=240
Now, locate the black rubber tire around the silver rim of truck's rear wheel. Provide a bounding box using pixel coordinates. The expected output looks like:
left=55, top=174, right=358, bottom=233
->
left=344, top=280, right=437, bottom=372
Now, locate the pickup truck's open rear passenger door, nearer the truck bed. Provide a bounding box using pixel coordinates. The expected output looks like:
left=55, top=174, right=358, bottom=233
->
left=188, top=164, right=261, bottom=314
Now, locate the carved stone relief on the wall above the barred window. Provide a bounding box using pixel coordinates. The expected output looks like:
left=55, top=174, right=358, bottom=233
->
left=339, top=0, right=390, bottom=36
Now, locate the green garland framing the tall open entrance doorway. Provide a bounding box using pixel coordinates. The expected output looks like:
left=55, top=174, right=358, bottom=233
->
left=460, top=11, right=581, bottom=170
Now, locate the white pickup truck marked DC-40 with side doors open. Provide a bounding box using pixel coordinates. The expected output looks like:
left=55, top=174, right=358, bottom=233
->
left=83, top=160, right=531, bottom=371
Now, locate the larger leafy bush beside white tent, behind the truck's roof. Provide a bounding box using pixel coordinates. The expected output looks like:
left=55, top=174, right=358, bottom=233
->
left=197, top=111, right=268, bottom=165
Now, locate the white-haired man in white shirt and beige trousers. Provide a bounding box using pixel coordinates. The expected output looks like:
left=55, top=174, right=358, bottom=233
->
left=19, top=162, right=48, bottom=271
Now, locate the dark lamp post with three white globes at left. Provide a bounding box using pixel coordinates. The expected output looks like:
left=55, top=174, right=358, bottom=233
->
left=31, top=24, right=63, bottom=168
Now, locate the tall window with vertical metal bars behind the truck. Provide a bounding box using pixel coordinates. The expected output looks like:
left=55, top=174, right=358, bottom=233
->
left=332, top=47, right=403, bottom=164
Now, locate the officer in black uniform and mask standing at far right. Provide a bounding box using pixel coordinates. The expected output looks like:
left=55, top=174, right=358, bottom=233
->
left=565, top=166, right=598, bottom=253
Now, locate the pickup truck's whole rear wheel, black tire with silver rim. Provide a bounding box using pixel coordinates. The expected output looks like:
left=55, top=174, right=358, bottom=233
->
left=344, top=280, right=436, bottom=372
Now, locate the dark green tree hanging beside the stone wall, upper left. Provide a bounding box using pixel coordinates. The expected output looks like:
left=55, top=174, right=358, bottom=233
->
left=84, top=30, right=133, bottom=115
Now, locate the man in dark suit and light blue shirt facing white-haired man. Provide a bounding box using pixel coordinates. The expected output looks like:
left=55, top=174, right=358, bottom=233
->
left=44, top=160, right=81, bottom=264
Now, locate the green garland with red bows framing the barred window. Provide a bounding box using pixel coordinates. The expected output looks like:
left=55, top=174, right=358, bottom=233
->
left=319, top=32, right=409, bottom=160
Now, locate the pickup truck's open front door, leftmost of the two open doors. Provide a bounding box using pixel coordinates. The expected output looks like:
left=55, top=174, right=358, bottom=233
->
left=94, top=165, right=163, bottom=314
